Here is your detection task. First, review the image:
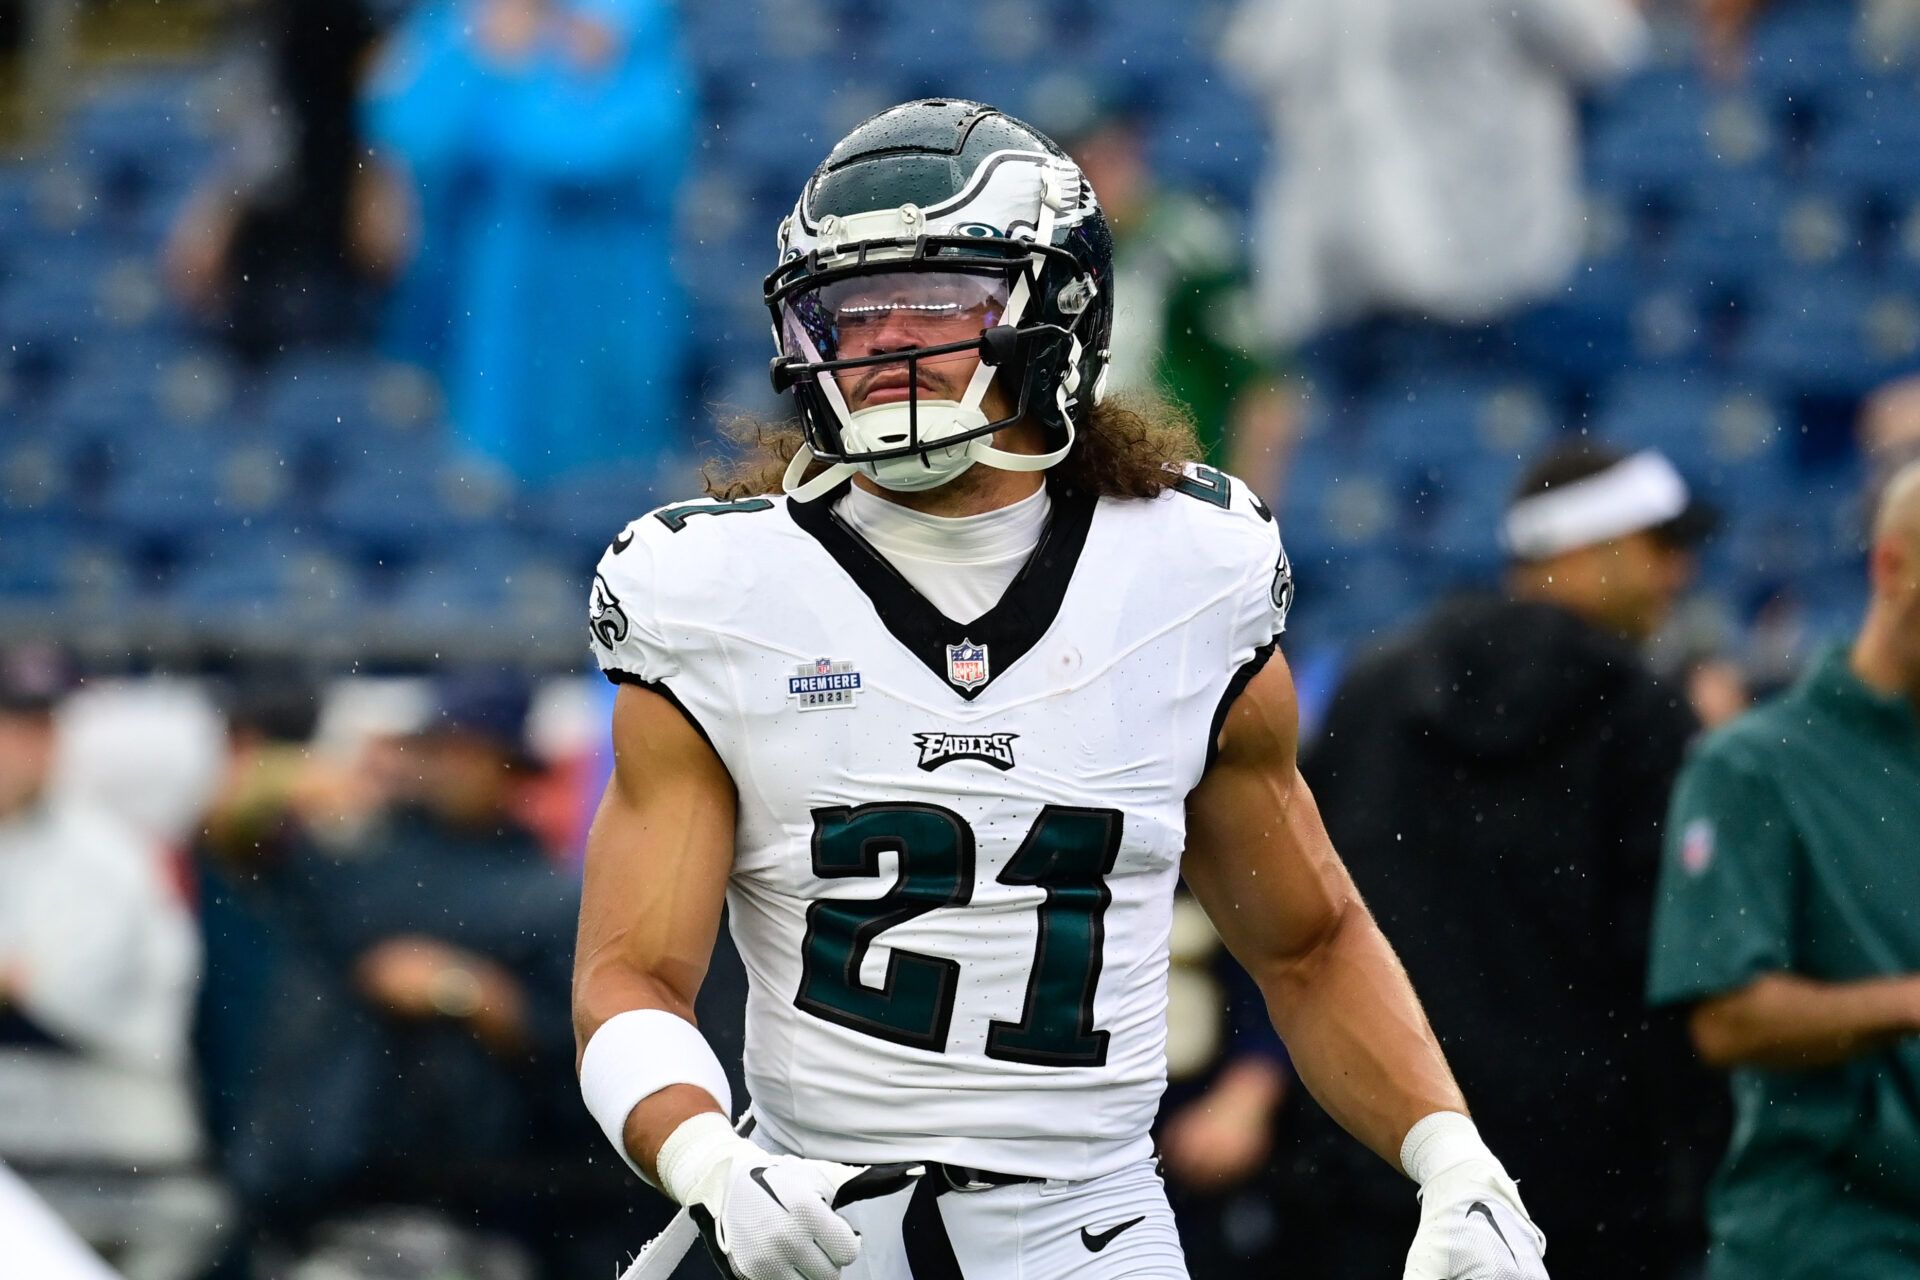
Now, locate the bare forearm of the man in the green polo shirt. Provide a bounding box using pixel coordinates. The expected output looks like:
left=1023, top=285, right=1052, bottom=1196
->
left=1692, top=973, right=1920, bottom=1071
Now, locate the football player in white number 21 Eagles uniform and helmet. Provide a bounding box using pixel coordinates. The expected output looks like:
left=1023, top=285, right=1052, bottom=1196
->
left=574, top=100, right=1546, bottom=1280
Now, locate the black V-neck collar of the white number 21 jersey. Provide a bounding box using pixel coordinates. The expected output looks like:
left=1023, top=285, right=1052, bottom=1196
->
left=787, top=482, right=1098, bottom=702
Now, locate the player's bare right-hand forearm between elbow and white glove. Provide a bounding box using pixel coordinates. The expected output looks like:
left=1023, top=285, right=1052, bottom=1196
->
left=1254, top=900, right=1467, bottom=1169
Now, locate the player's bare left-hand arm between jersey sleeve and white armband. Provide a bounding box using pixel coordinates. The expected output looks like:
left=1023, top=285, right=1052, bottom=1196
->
left=574, top=685, right=735, bottom=1046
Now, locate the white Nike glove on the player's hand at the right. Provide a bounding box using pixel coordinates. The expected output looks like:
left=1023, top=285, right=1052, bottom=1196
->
left=1400, top=1111, right=1548, bottom=1280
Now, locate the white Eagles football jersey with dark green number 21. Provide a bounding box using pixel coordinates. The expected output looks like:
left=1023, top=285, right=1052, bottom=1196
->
left=591, top=466, right=1292, bottom=1178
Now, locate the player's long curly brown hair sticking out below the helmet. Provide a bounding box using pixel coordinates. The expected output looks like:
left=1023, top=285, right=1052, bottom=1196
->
left=701, top=391, right=1200, bottom=501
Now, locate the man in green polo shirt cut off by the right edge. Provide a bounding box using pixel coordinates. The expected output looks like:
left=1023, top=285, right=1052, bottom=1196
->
left=1649, top=462, right=1920, bottom=1280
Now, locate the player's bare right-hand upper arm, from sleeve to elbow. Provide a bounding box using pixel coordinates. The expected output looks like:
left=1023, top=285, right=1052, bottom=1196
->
left=1183, top=654, right=1359, bottom=979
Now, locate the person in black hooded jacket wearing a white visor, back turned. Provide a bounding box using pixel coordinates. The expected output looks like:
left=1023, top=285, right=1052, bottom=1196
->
left=1298, top=447, right=1713, bottom=1280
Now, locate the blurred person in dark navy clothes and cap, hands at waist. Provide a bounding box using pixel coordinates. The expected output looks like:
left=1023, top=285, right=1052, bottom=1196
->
left=230, top=674, right=622, bottom=1276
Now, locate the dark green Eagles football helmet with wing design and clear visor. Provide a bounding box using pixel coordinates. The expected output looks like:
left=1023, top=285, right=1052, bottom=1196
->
left=764, top=98, right=1114, bottom=501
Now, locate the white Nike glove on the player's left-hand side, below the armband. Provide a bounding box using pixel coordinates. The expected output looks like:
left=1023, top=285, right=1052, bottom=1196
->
left=655, top=1111, right=925, bottom=1280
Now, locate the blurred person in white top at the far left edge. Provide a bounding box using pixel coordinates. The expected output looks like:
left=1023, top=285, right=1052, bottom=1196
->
left=0, top=647, right=223, bottom=1280
